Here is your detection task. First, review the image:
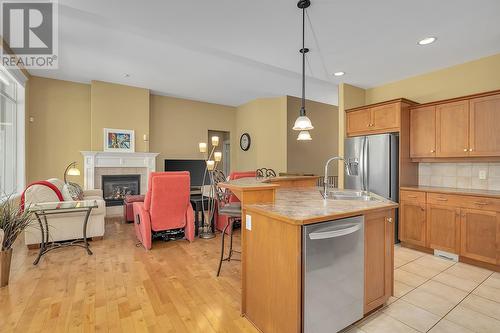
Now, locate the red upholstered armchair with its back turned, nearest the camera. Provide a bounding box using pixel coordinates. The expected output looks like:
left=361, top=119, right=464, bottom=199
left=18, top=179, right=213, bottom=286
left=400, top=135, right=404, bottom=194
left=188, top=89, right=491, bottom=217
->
left=133, top=171, right=194, bottom=250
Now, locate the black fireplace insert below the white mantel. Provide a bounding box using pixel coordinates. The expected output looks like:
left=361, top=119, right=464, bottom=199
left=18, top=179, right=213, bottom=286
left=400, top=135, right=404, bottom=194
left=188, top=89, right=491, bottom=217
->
left=101, top=175, right=141, bottom=206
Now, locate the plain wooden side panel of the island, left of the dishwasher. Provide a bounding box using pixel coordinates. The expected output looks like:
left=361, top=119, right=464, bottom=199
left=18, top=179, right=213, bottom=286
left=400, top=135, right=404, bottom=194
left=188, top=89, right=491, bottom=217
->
left=242, top=212, right=302, bottom=333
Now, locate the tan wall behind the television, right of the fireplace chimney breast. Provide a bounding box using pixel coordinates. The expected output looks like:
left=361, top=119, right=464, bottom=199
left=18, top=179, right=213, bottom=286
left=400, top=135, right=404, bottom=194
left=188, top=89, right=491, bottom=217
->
left=150, top=95, right=236, bottom=170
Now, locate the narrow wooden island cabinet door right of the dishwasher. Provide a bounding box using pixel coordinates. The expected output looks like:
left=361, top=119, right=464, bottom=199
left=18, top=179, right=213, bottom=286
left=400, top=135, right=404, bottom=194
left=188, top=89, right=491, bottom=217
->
left=364, top=210, right=394, bottom=313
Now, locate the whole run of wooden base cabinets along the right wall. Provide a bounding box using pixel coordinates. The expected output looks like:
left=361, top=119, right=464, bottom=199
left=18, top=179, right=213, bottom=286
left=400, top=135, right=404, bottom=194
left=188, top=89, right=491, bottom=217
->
left=399, top=190, right=500, bottom=271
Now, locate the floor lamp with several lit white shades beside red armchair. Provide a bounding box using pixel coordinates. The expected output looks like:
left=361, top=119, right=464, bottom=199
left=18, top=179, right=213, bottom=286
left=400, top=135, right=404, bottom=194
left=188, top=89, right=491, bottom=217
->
left=198, top=136, right=222, bottom=239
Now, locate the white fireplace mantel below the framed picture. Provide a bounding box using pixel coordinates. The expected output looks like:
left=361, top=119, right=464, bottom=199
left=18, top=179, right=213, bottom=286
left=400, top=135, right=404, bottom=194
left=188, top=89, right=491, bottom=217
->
left=81, top=151, right=158, bottom=190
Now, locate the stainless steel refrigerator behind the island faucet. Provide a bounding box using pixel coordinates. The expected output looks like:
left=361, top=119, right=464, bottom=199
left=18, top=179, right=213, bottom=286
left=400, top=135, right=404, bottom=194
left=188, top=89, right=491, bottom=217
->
left=344, top=133, right=399, bottom=242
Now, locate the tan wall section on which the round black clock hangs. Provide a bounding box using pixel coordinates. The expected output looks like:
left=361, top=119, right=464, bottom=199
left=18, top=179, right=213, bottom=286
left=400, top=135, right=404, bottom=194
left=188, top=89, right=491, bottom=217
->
left=233, top=96, right=287, bottom=172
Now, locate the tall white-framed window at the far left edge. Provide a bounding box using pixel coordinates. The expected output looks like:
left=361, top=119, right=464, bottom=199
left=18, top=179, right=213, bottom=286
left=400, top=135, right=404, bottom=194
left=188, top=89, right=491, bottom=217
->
left=0, top=67, right=18, bottom=197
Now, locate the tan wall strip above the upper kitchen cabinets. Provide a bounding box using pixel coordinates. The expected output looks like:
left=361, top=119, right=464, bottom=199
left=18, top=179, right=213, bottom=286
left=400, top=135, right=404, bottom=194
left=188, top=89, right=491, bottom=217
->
left=366, top=54, right=500, bottom=104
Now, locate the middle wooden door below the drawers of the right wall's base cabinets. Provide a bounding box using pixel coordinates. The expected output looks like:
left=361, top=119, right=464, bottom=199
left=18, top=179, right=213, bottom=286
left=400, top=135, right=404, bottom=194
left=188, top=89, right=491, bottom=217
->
left=427, top=204, right=460, bottom=254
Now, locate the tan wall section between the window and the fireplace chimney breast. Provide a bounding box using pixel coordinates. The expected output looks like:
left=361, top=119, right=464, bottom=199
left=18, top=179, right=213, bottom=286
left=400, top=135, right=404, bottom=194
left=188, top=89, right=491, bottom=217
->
left=26, top=76, right=90, bottom=184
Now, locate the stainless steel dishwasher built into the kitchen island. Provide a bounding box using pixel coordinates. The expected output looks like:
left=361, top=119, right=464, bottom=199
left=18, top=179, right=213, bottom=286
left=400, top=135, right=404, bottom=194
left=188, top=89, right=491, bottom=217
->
left=302, top=216, right=365, bottom=333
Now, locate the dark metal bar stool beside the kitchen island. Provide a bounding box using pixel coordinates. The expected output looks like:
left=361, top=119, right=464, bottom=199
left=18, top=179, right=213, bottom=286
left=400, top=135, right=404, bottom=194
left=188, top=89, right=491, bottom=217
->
left=213, top=170, right=241, bottom=276
